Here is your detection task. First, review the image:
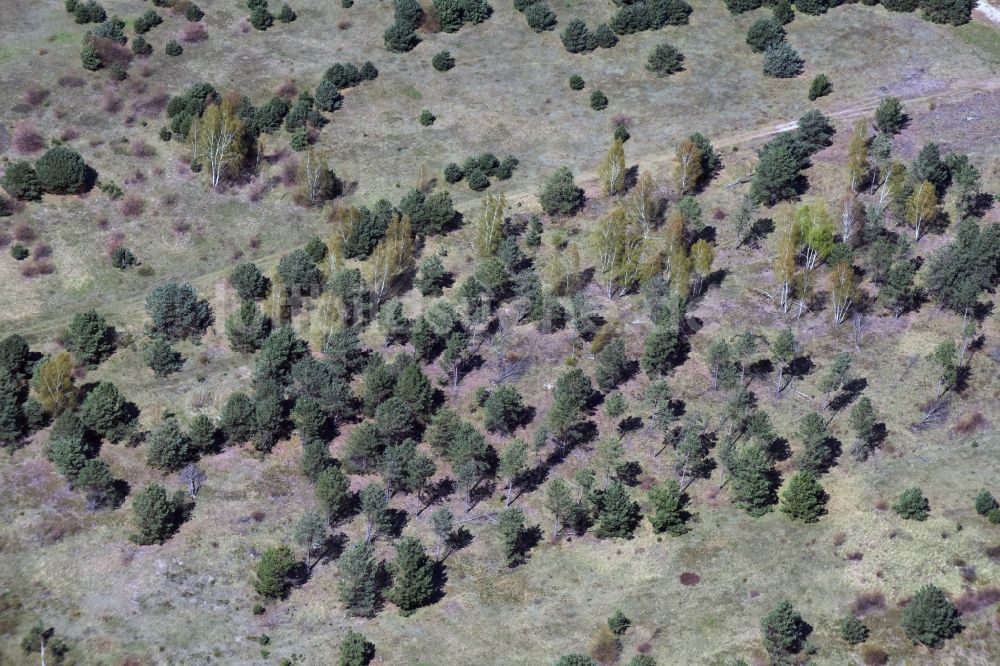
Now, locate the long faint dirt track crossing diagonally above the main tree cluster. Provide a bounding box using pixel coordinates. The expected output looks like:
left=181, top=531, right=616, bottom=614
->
left=7, top=76, right=1000, bottom=343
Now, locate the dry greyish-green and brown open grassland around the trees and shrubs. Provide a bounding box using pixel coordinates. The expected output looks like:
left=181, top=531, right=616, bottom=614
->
left=0, top=0, right=1000, bottom=665
